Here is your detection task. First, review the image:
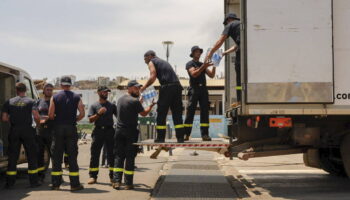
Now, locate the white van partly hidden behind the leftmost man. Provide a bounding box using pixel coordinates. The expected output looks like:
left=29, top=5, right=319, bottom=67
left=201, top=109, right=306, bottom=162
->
left=0, top=62, right=38, bottom=171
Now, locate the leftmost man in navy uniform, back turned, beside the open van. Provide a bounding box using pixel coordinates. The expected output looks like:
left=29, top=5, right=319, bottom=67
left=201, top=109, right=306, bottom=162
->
left=2, top=82, right=40, bottom=188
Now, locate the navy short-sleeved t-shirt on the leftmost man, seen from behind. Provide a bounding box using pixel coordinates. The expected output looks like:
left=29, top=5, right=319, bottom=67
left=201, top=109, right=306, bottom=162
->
left=2, top=96, right=35, bottom=127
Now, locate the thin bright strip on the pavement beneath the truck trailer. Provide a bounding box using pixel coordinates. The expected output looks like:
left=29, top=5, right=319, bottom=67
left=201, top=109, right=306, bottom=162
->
left=238, top=169, right=327, bottom=174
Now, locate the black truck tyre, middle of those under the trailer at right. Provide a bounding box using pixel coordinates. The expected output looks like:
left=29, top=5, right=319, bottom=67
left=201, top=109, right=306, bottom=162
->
left=319, top=148, right=346, bottom=176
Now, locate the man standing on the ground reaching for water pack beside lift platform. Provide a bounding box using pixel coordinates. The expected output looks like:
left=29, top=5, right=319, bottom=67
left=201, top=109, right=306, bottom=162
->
left=112, top=80, right=155, bottom=190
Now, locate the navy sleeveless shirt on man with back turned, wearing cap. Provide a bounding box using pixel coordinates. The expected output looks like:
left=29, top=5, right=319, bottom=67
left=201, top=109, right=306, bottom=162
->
left=53, top=90, right=80, bottom=125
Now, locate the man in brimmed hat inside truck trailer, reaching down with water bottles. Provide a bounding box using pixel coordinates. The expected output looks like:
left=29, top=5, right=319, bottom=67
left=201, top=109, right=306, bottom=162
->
left=206, top=13, right=242, bottom=106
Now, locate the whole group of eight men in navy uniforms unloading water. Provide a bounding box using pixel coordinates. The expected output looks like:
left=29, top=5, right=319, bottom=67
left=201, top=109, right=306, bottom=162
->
left=1, top=13, right=241, bottom=191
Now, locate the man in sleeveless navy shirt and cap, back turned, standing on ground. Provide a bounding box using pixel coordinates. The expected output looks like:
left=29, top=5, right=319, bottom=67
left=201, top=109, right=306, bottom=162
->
left=49, top=76, right=85, bottom=191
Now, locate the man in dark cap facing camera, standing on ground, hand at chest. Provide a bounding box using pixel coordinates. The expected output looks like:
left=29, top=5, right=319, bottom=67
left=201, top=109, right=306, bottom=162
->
left=88, top=86, right=117, bottom=184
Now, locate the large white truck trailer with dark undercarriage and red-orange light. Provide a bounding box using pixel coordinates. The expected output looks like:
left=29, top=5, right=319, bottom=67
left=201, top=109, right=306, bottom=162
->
left=225, top=0, right=350, bottom=176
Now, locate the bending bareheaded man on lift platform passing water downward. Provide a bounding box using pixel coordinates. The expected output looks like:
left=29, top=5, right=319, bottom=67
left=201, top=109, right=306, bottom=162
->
left=140, top=50, right=184, bottom=143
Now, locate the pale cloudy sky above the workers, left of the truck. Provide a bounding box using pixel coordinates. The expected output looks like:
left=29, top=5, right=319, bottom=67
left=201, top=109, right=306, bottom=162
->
left=0, top=0, right=224, bottom=80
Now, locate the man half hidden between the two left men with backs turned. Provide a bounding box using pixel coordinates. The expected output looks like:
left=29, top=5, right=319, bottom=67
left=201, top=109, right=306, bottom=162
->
left=34, top=83, right=54, bottom=180
